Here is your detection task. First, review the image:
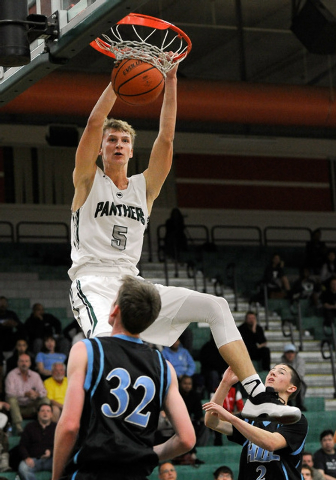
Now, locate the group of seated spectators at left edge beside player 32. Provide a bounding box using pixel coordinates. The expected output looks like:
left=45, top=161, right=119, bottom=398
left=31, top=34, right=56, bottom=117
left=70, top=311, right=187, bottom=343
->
left=0, top=296, right=70, bottom=480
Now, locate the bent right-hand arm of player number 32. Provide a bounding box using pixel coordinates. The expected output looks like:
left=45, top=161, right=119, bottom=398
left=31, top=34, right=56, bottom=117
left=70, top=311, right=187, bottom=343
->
left=154, top=362, right=196, bottom=461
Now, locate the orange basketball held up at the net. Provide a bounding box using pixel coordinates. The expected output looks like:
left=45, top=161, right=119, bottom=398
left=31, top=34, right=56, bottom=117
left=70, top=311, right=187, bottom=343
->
left=111, top=59, right=164, bottom=106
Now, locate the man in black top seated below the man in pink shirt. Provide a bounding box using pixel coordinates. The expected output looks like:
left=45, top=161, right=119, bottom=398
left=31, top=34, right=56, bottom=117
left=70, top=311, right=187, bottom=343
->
left=18, top=404, right=56, bottom=480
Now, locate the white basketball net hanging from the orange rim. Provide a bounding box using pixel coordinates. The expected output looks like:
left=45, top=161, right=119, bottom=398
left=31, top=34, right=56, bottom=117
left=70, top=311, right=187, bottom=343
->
left=96, top=25, right=188, bottom=76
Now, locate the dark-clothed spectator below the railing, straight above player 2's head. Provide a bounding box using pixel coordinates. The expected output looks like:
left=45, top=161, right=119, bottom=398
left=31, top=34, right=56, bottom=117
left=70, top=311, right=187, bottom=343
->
left=262, top=253, right=290, bottom=298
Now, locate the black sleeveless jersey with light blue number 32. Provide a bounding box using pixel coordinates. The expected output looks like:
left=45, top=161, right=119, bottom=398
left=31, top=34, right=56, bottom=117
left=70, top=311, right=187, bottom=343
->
left=73, top=335, right=170, bottom=480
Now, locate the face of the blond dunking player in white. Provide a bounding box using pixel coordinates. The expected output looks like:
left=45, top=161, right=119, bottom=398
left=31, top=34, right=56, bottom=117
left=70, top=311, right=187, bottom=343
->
left=100, top=128, right=133, bottom=167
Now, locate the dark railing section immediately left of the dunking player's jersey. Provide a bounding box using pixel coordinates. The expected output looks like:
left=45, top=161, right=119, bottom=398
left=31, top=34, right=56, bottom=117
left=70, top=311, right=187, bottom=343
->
left=16, top=222, right=70, bottom=243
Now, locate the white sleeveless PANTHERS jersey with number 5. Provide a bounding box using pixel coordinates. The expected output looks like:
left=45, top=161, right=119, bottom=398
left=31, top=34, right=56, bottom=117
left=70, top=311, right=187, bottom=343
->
left=68, top=167, right=148, bottom=280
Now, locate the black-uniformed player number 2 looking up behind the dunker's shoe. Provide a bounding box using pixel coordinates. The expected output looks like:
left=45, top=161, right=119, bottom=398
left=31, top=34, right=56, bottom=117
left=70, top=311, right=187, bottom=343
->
left=203, top=364, right=308, bottom=480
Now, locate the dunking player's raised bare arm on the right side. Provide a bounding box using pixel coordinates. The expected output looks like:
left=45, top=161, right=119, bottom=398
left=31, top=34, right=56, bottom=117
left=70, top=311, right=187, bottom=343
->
left=144, top=65, right=177, bottom=211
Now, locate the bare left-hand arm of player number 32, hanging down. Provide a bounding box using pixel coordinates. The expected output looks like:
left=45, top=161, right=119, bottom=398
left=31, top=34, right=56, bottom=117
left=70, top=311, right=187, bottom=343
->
left=52, top=342, right=87, bottom=480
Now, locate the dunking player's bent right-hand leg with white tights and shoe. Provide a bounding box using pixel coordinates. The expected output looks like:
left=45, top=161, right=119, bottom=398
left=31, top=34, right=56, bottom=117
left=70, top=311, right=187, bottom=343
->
left=144, top=285, right=301, bottom=423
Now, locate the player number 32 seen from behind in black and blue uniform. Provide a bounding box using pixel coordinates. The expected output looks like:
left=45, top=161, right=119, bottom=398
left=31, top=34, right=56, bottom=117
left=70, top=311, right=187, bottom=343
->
left=52, top=276, right=196, bottom=480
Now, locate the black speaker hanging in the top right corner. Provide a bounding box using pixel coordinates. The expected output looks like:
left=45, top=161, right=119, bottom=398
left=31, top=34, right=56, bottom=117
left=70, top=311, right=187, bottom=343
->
left=290, top=0, right=336, bottom=55
